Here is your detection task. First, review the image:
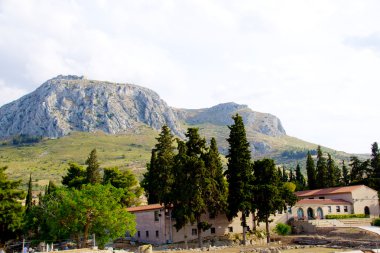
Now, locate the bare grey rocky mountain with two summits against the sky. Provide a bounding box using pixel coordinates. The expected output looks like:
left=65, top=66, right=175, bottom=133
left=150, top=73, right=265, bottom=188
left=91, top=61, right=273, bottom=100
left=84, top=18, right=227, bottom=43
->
left=0, top=75, right=286, bottom=148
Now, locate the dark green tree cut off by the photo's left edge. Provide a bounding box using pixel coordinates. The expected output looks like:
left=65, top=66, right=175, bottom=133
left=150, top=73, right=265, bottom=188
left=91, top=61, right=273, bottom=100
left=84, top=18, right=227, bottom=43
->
left=0, top=167, right=25, bottom=247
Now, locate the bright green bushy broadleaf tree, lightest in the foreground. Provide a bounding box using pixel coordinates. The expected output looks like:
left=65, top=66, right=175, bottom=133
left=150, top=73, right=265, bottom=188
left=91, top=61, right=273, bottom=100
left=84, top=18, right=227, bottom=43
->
left=27, top=184, right=136, bottom=248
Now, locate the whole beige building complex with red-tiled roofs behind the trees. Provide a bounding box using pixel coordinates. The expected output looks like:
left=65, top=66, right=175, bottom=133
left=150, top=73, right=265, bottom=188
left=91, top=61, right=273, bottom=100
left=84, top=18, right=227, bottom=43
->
left=127, top=185, right=380, bottom=244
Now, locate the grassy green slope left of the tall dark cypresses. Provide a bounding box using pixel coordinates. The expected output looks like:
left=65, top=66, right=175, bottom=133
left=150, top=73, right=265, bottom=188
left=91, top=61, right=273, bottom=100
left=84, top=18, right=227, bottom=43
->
left=0, top=126, right=158, bottom=188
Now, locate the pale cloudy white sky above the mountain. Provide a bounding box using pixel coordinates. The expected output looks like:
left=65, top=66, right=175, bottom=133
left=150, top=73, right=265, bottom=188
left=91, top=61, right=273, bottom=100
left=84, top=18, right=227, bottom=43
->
left=0, top=0, right=380, bottom=153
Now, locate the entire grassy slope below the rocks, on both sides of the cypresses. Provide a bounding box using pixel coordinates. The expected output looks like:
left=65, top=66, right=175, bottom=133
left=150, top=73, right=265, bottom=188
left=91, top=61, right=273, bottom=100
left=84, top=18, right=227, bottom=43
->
left=0, top=123, right=362, bottom=189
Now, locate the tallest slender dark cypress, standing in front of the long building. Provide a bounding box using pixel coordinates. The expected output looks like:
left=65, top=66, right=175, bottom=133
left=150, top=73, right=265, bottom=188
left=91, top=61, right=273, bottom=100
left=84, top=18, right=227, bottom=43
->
left=225, top=114, right=254, bottom=244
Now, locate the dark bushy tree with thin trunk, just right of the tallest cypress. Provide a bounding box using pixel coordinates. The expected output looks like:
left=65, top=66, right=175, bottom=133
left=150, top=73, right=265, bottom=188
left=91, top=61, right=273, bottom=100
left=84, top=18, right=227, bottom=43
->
left=253, top=159, right=297, bottom=243
